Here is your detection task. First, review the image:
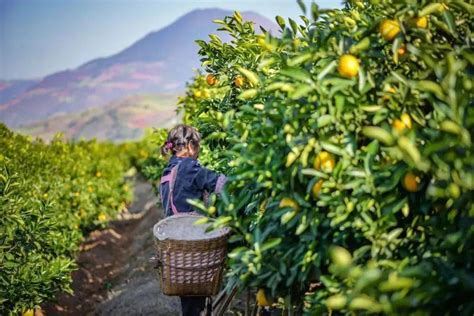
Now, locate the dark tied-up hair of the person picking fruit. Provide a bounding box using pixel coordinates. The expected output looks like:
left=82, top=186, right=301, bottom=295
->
left=161, top=124, right=201, bottom=155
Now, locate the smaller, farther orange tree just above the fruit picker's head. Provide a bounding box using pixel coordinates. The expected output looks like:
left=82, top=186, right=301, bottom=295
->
left=179, top=12, right=265, bottom=171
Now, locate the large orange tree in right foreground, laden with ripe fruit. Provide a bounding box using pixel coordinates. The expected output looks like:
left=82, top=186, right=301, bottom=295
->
left=179, top=0, right=474, bottom=315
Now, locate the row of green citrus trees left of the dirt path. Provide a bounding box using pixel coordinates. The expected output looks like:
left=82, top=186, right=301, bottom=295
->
left=0, top=125, right=159, bottom=315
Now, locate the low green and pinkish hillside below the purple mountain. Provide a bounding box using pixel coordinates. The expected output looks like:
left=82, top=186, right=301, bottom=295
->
left=19, top=94, right=178, bottom=142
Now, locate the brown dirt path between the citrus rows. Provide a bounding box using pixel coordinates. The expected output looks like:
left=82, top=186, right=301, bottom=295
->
left=42, top=177, right=252, bottom=316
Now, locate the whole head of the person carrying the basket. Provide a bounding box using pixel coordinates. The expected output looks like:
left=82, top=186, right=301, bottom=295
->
left=161, top=124, right=201, bottom=159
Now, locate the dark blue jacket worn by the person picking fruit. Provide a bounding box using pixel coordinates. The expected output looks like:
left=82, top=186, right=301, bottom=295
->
left=160, top=156, right=225, bottom=216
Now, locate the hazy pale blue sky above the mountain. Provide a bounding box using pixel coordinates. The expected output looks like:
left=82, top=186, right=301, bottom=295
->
left=0, top=0, right=341, bottom=79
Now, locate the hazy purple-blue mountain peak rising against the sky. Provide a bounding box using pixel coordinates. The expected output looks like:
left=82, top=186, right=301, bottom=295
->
left=0, top=9, right=277, bottom=127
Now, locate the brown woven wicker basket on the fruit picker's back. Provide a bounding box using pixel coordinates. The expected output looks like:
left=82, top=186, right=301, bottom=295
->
left=153, top=215, right=230, bottom=296
